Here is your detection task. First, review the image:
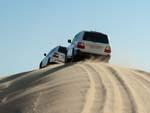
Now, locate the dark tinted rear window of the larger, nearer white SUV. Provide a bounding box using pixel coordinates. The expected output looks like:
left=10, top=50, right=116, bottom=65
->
left=83, top=32, right=109, bottom=44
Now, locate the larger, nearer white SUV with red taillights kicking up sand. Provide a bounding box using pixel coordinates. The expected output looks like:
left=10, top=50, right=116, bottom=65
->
left=66, top=31, right=111, bottom=62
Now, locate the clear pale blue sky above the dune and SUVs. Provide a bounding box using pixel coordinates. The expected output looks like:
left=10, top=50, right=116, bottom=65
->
left=0, top=0, right=150, bottom=76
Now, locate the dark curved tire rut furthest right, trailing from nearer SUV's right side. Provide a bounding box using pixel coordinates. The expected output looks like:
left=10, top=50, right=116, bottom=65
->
left=107, top=66, right=138, bottom=113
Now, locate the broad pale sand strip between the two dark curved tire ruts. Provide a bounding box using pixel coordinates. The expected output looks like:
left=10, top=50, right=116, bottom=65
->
left=91, top=63, right=127, bottom=113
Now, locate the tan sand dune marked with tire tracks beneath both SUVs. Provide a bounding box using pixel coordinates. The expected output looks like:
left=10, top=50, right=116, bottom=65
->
left=0, top=61, right=150, bottom=113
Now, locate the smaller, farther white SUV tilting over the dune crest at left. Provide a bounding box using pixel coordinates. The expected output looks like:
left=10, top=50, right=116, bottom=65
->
left=39, top=46, right=67, bottom=68
